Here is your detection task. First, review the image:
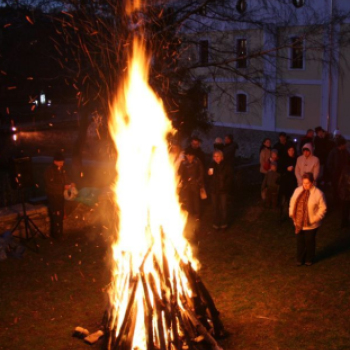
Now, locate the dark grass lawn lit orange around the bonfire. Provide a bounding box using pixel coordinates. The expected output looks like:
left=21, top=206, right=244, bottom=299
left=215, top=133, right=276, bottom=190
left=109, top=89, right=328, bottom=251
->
left=0, top=188, right=350, bottom=350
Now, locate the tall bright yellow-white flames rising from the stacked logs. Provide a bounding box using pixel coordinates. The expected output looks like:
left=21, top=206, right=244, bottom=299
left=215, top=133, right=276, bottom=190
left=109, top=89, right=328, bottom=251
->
left=109, top=40, right=196, bottom=350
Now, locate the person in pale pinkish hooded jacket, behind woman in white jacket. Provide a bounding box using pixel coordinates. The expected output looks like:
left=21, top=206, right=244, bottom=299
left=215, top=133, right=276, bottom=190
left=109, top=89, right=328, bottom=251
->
left=295, top=143, right=320, bottom=186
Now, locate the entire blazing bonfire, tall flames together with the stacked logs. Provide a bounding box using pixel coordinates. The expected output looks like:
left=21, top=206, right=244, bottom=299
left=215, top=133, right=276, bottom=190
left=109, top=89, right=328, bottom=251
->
left=106, top=5, right=223, bottom=350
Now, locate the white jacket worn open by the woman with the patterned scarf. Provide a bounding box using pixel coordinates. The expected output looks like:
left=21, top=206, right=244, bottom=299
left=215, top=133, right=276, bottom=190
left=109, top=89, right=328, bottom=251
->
left=289, top=186, right=327, bottom=230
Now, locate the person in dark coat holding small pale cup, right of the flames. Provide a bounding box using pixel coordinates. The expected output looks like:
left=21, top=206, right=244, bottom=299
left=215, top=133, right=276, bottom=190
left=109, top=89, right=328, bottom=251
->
left=208, top=150, right=232, bottom=230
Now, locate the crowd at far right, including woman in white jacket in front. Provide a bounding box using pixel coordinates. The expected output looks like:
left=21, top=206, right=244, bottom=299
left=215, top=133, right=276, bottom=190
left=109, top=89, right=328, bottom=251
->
left=260, top=126, right=350, bottom=266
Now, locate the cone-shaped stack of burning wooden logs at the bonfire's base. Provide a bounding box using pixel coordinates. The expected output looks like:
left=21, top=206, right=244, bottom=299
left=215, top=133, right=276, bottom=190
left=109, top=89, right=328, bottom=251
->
left=102, top=253, right=227, bottom=350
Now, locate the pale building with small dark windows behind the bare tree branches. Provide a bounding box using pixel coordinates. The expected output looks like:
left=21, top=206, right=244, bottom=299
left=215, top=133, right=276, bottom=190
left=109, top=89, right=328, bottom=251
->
left=181, top=0, right=350, bottom=145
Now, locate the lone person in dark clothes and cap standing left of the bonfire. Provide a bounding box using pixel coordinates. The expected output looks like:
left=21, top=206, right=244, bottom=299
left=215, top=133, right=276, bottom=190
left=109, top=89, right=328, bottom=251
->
left=44, top=152, right=75, bottom=239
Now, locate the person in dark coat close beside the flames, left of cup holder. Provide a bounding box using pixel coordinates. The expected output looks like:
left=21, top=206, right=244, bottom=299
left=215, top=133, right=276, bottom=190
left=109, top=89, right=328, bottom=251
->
left=178, top=148, right=204, bottom=220
